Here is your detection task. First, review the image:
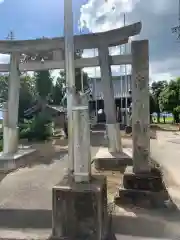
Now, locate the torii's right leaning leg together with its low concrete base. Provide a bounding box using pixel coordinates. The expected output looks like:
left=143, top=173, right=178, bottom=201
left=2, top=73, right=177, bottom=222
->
left=94, top=42, right=132, bottom=170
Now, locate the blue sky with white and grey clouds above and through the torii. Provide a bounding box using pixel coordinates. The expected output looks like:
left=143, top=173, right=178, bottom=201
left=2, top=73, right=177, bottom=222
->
left=0, top=0, right=180, bottom=80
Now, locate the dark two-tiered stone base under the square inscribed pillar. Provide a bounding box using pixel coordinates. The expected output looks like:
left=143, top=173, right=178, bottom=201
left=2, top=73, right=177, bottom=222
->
left=115, top=167, right=168, bottom=207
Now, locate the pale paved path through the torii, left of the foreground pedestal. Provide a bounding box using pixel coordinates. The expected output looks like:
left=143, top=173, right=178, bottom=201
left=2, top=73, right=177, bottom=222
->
left=0, top=134, right=103, bottom=240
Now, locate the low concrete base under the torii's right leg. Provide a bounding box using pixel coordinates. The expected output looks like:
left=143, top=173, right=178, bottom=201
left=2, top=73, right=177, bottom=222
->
left=93, top=148, right=132, bottom=171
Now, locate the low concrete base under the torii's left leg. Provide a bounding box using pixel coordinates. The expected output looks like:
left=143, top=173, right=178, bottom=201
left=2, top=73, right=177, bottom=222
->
left=0, top=147, right=36, bottom=172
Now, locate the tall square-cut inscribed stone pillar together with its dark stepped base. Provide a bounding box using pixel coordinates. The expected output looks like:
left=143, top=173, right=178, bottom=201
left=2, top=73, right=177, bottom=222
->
left=119, top=40, right=165, bottom=206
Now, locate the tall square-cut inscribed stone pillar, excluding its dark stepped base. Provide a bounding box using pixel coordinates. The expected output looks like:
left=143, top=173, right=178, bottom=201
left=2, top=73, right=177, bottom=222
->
left=132, top=40, right=150, bottom=173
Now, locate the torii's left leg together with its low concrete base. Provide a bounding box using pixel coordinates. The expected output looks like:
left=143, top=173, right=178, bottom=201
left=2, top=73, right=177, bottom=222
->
left=0, top=52, right=36, bottom=172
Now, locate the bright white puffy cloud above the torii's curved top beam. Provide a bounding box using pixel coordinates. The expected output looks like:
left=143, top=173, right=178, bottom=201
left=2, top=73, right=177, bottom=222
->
left=80, top=0, right=140, bottom=32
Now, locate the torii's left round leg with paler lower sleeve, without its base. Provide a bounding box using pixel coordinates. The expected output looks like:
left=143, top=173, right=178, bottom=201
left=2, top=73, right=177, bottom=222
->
left=8, top=53, right=20, bottom=153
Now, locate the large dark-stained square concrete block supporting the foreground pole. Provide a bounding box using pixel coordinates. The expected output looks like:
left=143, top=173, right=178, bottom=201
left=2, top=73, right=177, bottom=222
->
left=53, top=176, right=108, bottom=240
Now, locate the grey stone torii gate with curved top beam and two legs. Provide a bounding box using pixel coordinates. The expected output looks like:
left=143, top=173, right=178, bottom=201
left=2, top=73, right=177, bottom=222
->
left=0, top=22, right=141, bottom=170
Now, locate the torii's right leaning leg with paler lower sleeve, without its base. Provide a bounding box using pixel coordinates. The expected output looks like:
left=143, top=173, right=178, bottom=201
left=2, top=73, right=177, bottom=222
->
left=99, top=41, right=122, bottom=152
